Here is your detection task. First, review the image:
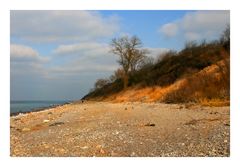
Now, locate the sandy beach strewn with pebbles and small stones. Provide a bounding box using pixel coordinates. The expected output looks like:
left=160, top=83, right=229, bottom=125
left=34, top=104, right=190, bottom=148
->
left=10, top=101, right=230, bottom=157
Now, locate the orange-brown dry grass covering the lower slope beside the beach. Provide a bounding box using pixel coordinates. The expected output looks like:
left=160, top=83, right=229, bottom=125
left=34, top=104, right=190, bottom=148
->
left=101, top=60, right=230, bottom=106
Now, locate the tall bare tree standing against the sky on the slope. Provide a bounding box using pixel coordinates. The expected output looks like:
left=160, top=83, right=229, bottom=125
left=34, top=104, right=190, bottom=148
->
left=111, top=36, right=147, bottom=89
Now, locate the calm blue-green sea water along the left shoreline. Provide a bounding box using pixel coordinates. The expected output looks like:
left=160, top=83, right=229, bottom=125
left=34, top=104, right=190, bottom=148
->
left=10, top=101, right=69, bottom=113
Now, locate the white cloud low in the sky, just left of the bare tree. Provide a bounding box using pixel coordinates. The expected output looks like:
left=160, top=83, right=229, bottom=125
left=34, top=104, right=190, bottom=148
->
left=50, top=42, right=118, bottom=75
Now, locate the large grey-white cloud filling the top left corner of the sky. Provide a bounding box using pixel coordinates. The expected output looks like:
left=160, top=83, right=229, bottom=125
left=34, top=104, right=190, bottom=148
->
left=11, top=11, right=119, bottom=42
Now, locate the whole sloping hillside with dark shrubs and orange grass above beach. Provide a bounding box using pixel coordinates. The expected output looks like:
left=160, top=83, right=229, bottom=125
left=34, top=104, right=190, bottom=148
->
left=83, top=39, right=230, bottom=104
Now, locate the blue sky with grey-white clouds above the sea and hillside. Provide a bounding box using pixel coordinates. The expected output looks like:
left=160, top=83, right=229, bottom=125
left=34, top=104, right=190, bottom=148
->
left=10, top=10, right=230, bottom=100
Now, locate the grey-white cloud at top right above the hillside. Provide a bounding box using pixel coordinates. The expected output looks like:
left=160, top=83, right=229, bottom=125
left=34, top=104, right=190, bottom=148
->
left=159, top=11, right=230, bottom=40
